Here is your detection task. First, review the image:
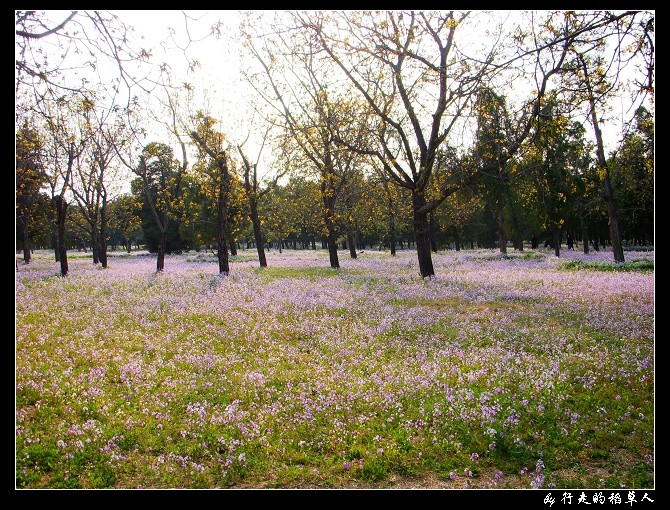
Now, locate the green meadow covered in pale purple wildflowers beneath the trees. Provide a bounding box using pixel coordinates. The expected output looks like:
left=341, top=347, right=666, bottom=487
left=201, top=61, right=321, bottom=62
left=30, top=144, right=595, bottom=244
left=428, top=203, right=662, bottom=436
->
left=15, top=250, right=655, bottom=489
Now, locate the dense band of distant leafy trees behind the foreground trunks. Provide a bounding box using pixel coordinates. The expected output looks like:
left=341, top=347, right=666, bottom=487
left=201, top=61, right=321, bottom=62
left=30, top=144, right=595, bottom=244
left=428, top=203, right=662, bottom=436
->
left=16, top=103, right=654, bottom=257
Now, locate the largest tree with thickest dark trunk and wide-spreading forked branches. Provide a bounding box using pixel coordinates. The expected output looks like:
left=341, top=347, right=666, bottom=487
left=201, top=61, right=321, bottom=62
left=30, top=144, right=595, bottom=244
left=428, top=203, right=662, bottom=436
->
left=295, top=11, right=574, bottom=277
